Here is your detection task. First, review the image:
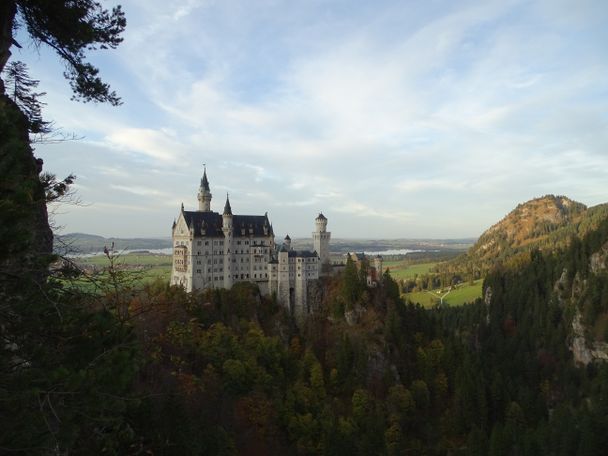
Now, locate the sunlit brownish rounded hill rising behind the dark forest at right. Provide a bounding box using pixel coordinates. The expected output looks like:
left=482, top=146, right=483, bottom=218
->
left=445, top=195, right=608, bottom=276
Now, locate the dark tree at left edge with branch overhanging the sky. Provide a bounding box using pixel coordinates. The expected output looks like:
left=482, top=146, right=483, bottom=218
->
left=0, top=0, right=126, bottom=282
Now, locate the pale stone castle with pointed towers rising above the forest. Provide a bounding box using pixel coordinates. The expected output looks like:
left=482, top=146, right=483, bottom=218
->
left=171, top=169, right=331, bottom=316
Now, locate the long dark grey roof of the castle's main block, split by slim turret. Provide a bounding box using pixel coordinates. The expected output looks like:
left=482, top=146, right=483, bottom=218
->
left=184, top=211, right=272, bottom=237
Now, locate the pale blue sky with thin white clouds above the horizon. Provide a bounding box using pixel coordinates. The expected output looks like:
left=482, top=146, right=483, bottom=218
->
left=12, top=0, right=608, bottom=239
